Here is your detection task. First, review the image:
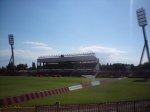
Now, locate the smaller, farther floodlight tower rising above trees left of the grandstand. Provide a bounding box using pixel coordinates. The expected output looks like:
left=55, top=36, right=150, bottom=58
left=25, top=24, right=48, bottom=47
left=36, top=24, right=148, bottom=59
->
left=8, top=34, right=15, bottom=70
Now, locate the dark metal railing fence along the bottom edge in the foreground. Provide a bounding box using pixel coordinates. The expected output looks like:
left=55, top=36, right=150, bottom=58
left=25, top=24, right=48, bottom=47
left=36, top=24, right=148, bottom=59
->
left=35, top=100, right=150, bottom=112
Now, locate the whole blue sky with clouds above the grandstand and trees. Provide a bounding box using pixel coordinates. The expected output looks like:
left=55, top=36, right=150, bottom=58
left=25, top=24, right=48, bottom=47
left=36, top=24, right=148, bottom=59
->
left=0, top=0, right=150, bottom=66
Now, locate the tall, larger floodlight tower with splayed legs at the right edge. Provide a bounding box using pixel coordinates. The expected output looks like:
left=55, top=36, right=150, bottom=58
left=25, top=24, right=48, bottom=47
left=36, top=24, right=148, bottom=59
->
left=136, top=8, right=150, bottom=65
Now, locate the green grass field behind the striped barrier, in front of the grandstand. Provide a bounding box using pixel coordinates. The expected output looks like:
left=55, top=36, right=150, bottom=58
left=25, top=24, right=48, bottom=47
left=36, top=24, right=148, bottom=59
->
left=0, top=76, right=86, bottom=98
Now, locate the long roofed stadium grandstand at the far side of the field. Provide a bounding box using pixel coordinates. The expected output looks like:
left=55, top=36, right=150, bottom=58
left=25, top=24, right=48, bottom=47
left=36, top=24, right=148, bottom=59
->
left=37, top=53, right=99, bottom=76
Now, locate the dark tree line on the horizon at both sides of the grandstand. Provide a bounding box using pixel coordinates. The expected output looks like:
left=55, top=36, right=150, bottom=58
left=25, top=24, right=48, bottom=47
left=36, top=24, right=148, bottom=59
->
left=0, top=62, right=150, bottom=71
